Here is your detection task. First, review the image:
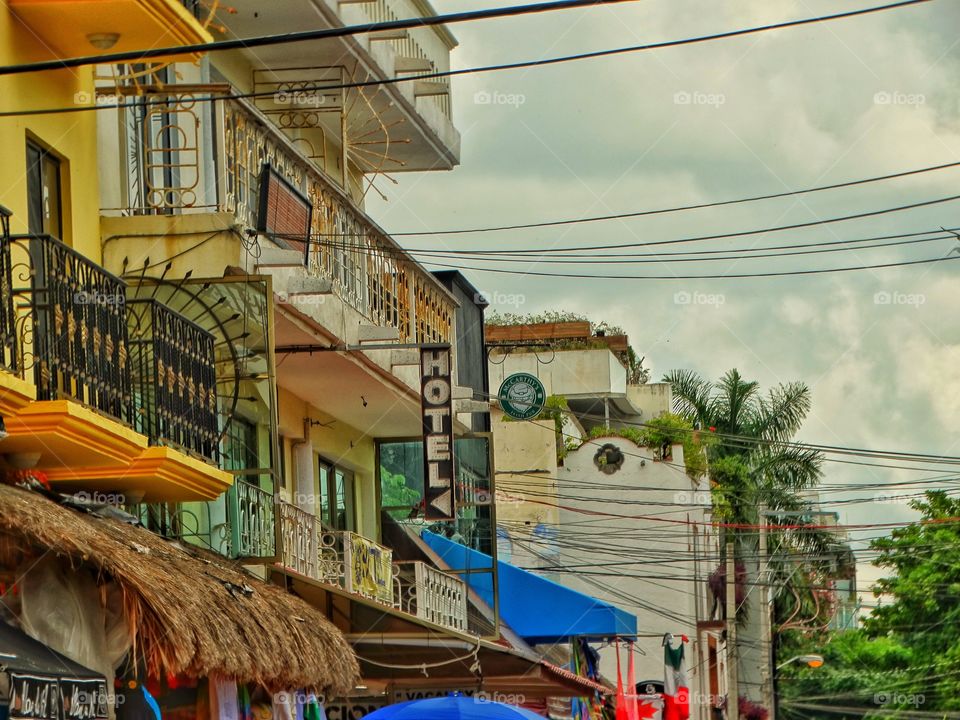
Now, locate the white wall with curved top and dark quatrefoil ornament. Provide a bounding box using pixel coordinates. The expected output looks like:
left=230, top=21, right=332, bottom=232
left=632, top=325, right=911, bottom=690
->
left=544, top=437, right=716, bottom=718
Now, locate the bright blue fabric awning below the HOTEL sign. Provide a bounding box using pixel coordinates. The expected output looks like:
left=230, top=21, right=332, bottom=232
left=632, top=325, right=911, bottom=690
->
left=422, top=531, right=637, bottom=644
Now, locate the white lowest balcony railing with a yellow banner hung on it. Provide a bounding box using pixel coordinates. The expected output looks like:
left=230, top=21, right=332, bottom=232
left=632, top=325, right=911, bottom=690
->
left=278, top=502, right=468, bottom=632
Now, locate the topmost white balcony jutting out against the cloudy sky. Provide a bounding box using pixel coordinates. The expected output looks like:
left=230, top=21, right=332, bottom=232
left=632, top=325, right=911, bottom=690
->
left=214, top=0, right=460, bottom=172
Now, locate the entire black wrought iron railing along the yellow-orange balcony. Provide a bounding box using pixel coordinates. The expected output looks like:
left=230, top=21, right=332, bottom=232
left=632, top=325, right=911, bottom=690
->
left=0, top=235, right=225, bottom=461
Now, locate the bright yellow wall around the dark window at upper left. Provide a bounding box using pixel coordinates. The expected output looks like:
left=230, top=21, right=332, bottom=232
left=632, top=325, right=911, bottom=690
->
left=0, top=1, right=100, bottom=262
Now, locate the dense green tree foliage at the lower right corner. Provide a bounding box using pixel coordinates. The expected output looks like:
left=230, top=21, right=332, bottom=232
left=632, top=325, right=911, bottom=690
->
left=780, top=491, right=960, bottom=720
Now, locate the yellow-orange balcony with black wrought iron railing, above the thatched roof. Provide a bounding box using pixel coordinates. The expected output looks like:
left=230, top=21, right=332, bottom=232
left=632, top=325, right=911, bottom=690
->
left=0, top=236, right=232, bottom=500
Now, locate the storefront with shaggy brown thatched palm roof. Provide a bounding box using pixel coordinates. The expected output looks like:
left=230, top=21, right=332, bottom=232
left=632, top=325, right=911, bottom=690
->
left=0, top=485, right=359, bottom=720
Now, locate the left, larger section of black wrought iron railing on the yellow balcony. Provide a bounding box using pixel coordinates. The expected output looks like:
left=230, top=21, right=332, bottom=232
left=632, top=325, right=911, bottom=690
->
left=9, top=235, right=134, bottom=423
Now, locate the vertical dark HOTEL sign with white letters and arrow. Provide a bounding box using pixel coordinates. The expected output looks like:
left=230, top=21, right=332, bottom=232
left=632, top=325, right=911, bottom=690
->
left=420, top=345, right=456, bottom=521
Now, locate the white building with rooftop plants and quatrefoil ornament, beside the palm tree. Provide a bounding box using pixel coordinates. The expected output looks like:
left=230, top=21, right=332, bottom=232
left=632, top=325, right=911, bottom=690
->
left=488, top=326, right=724, bottom=720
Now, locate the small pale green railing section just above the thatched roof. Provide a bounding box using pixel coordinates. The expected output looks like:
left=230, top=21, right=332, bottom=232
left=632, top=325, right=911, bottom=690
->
left=227, top=478, right=277, bottom=559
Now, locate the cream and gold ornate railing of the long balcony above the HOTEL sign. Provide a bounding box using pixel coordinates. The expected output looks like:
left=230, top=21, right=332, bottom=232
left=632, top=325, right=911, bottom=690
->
left=107, top=86, right=454, bottom=342
